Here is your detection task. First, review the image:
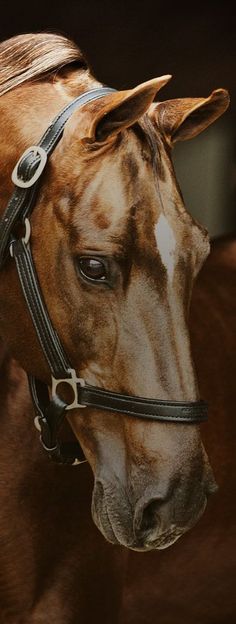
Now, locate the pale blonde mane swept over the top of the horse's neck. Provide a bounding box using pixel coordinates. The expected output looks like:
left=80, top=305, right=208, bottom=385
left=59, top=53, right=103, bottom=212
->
left=0, top=32, right=88, bottom=95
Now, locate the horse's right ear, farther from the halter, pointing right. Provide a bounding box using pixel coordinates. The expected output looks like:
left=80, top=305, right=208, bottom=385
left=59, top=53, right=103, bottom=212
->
left=150, top=89, right=229, bottom=144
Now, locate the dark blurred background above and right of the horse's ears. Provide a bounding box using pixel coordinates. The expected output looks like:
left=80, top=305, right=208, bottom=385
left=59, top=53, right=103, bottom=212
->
left=0, top=0, right=236, bottom=237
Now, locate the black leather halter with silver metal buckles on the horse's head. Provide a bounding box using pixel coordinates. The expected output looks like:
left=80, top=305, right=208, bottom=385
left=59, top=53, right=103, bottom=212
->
left=0, top=87, right=207, bottom=464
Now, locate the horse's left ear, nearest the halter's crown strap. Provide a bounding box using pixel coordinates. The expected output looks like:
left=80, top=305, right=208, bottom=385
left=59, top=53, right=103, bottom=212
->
left=86, top=75, right=171, bottom=141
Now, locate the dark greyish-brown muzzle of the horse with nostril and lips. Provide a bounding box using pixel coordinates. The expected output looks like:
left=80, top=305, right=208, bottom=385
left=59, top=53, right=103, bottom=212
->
left=92, top=472, right=210, bottom=551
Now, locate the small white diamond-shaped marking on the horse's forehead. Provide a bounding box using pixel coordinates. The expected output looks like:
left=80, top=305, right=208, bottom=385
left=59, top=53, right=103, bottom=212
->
left=155, top=215, right=176, bottom=281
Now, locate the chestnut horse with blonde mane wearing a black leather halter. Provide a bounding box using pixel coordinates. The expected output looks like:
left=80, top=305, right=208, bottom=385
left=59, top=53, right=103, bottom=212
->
left=0, top=33, right=232, bottom=624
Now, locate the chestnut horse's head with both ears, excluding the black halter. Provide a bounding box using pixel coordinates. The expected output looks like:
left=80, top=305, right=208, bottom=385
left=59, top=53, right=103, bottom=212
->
left=0, top=34, right=228, bottom=550
